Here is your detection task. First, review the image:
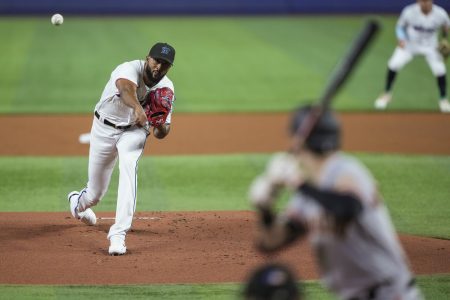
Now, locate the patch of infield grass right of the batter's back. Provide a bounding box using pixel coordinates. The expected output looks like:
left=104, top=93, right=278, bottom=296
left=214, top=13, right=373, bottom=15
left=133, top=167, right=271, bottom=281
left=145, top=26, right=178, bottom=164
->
left=359, top=154, right=450, bottom=238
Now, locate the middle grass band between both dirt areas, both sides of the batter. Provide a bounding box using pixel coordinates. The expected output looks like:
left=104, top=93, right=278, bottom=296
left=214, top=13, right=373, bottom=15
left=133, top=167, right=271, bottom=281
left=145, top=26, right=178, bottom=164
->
left=0, top=154, right=450, bottom=238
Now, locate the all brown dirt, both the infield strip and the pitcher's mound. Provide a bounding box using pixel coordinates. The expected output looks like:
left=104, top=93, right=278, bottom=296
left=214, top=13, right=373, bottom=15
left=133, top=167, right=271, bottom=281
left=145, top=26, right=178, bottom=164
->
left=0, top=113, right=450, bottom=284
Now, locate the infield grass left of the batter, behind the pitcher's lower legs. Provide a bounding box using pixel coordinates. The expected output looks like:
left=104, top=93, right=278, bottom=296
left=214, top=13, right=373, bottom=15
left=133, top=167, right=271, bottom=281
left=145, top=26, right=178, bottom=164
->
left=0, top=155, right=265, bottom=211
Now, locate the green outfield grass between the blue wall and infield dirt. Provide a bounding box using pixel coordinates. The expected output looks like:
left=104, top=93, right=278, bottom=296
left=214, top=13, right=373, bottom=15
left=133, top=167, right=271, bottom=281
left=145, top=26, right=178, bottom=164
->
left=0, top=16, right=446, bottom=113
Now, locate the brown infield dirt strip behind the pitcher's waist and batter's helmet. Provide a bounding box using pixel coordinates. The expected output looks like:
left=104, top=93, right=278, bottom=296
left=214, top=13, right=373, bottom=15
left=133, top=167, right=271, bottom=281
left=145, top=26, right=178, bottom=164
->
left=0, top=113, right=450, bottom=156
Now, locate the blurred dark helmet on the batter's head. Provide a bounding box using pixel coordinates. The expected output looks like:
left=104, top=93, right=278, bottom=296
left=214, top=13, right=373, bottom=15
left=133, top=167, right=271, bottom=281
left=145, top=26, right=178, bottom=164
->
left=290, top=106, right=341, bottom=154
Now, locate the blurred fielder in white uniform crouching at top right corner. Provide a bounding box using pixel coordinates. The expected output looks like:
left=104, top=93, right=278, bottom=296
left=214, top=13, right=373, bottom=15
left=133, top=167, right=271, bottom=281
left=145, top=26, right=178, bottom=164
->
left=375, top=0, right=450, bottom=113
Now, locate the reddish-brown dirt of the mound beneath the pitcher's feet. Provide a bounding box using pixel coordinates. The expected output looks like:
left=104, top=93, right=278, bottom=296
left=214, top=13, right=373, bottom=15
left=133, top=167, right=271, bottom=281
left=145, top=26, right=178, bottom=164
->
left=0, top=211, right=450, bottom=284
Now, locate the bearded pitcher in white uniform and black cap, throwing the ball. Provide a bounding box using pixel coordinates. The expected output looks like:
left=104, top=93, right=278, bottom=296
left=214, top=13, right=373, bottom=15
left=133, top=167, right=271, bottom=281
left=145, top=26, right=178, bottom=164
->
left=68, top=43, right=175, bottom=255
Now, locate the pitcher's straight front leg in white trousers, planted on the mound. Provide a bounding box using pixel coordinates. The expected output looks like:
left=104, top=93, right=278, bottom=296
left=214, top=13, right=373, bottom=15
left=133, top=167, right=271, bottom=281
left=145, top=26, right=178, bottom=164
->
left=108, top=127, right=146, bottom=255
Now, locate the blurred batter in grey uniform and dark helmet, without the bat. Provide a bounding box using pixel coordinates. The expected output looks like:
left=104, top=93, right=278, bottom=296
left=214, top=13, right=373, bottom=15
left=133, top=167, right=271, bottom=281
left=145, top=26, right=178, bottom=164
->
left=249, top=107, right=422, bottom=300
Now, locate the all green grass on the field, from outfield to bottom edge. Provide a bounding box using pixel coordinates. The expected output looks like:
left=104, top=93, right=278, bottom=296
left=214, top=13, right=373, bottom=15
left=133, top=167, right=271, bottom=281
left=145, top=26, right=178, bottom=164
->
left=0, top=16, right=450, bottom=300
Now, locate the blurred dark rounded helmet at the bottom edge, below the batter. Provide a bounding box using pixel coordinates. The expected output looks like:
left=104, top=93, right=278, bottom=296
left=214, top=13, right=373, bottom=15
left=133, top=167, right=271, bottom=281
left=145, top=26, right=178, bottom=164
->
left=243, top=264, right=301, bottom=300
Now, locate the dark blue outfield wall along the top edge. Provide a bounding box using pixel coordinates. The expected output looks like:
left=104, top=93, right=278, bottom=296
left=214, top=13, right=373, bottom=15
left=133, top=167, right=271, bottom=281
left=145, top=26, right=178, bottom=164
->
left=0, top=0, right=450, bottom=15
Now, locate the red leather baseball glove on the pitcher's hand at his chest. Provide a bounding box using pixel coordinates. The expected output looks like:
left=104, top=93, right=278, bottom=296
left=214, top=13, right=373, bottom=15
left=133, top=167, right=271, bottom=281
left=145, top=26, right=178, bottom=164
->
left=144, top=87, right=174, bottom=126
